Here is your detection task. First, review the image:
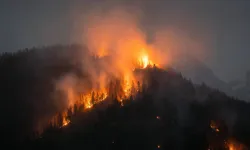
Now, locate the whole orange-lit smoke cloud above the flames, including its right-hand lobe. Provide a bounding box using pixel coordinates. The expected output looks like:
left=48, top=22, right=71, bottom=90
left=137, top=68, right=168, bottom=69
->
left=56, top=6, right=213, bottom=125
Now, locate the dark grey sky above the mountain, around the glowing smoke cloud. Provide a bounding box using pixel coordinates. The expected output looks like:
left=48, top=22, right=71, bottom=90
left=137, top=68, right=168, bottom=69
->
left=0, top=0, right=250, bottom=81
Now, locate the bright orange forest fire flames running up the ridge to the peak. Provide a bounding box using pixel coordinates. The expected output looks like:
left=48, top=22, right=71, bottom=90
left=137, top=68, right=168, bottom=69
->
left=47, top=49, right=156, bottom=127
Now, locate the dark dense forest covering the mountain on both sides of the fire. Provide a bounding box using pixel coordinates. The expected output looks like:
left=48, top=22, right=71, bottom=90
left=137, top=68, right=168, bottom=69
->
left=0, top=45, right=250, bottom=149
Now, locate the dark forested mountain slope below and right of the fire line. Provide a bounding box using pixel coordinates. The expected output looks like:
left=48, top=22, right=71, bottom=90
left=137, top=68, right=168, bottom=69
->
left=27, top=68, right=250, bottom=149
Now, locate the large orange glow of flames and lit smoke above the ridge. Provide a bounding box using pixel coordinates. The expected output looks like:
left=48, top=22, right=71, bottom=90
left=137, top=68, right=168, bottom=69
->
left=47, top=9, right=162, bottom=129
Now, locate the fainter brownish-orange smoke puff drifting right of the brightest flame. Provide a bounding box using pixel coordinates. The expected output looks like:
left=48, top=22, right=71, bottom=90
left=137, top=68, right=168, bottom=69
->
left=153, top=27, right=207, bottom=65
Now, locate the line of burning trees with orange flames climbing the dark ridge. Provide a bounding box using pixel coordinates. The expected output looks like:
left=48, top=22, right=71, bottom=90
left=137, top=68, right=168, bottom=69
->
left=45, top=49, right=155, bottom=131
